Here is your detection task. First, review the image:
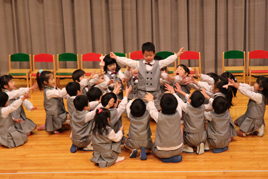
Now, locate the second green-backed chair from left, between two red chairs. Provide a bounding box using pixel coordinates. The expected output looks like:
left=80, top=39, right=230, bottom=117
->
left=55, top=53, right=79, bottom=85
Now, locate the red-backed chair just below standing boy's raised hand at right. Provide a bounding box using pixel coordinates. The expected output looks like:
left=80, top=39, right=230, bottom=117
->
left=178, top=51, right=201, bottom=74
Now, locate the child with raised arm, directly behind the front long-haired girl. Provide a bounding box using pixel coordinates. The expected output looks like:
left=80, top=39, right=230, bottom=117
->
left=101, top=86, right=132, bottom=143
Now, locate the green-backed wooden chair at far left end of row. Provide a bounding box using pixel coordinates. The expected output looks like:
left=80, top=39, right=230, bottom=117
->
left=8, top=53, right=32, bottom=87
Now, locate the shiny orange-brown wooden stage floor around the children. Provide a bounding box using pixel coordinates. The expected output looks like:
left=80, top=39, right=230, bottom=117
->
left=0, top=81, right=268, bottom=179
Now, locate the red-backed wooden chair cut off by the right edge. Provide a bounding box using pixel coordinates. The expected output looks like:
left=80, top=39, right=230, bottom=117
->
left=248, top=50, right=268, bottom=84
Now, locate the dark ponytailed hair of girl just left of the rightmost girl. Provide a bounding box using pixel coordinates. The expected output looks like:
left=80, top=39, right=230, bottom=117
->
left=214, top=77, right=233, bottom=109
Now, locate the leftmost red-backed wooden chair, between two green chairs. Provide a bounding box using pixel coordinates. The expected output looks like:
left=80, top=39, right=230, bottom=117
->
left=30, top=53, right=56, bottom=86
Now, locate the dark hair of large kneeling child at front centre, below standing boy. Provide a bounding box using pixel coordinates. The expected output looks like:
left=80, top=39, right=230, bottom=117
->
left=160, top=93, right=178, bottom=114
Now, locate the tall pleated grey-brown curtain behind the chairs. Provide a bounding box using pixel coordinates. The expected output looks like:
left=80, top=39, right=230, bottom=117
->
left=0, top=0, right=268, bottom=75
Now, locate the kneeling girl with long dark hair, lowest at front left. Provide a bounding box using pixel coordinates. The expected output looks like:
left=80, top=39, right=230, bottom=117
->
left=90, top=108, right=125, bottom=168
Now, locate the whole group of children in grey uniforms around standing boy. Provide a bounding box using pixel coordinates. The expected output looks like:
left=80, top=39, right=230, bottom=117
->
left=0, top=42, right=268, bottom=167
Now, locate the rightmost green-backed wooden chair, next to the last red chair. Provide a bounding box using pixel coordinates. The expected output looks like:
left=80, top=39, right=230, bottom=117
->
left=222, top=50, right=246, bottom=83
